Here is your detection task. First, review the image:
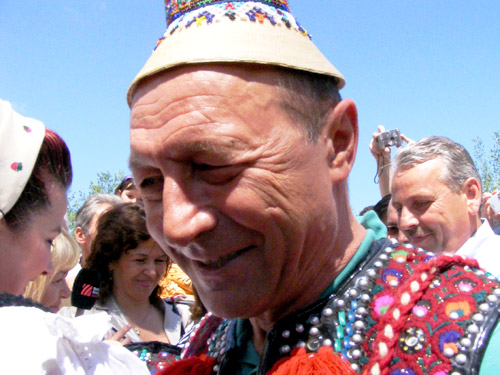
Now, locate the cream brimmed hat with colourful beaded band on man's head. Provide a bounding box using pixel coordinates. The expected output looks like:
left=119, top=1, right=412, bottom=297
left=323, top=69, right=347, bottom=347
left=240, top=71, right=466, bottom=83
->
left=127, top=0, right=345, bottom=105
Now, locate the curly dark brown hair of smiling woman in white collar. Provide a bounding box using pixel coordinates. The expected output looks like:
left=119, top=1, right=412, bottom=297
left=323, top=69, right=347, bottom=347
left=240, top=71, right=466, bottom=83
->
left=87, top=203, right=170, bottom=303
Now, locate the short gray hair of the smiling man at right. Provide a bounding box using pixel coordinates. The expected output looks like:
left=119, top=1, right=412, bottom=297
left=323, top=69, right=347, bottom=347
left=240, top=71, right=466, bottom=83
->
left=393, top=137, right=482, bottom=193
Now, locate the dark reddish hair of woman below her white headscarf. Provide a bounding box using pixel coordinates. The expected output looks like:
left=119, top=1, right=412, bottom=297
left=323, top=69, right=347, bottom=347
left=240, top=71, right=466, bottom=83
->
left=4, top=129, right=73, bottom=231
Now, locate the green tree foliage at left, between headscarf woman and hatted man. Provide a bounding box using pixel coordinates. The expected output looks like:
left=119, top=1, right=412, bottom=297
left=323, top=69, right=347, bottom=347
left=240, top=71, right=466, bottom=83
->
left=68, top=171, right=125, bottom=233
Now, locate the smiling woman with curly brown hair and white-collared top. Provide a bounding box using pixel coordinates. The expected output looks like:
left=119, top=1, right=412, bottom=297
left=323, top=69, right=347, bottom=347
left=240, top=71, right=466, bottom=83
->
left=72, top=204, right=192, bottom=345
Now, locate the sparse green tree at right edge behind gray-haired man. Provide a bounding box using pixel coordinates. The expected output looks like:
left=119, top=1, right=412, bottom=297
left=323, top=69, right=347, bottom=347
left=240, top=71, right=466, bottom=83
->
left=474, top=131, right=500, bottom=192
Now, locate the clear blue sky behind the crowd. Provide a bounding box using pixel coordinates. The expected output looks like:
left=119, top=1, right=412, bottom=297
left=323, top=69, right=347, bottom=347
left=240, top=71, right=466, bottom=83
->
left=0, top=0, right=500, bottom=213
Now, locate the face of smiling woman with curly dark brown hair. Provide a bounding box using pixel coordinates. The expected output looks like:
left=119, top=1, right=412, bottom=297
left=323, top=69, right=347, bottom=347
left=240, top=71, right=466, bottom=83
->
left=110, top=240, right=168, bottom=302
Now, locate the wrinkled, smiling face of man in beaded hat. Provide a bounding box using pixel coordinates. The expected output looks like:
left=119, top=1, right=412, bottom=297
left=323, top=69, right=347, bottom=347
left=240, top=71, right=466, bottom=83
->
left=131, top=66, right=348, bottom=317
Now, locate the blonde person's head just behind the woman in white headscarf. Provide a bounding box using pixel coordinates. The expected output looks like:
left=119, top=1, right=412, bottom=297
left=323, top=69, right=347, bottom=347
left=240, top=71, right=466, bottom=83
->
left=24, top=229, right=80, bottom=313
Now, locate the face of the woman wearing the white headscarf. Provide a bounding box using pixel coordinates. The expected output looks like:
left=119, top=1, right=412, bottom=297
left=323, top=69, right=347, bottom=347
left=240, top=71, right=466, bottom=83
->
left=0, top=183, right=67, bottom=295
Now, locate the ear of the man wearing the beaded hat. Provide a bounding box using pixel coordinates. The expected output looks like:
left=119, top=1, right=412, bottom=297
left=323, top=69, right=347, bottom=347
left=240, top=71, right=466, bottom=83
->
left=324, top=99, right=359, bottom=184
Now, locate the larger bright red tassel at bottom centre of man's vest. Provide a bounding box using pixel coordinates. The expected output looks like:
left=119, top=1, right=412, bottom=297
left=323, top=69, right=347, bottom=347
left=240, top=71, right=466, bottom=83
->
left=266, top=346, right=356, bottom=375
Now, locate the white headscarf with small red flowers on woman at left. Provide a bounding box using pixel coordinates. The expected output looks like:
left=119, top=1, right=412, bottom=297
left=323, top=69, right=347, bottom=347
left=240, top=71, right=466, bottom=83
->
left=0, top=99, right=45, bottom=219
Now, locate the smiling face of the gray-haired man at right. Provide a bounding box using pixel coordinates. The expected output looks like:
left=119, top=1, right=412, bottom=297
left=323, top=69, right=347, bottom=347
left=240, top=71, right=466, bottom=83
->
left=392, top=158, right=473, bottom=253
